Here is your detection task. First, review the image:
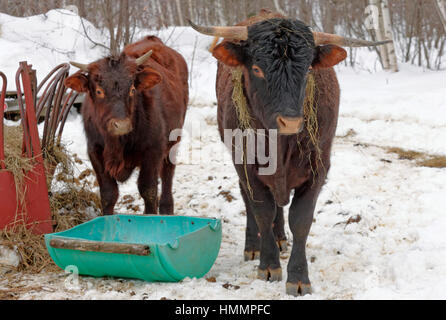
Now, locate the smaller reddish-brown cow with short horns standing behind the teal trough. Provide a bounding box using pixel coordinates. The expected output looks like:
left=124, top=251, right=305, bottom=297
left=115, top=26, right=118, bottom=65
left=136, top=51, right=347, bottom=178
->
left=66, top=36, right=188, bottom=214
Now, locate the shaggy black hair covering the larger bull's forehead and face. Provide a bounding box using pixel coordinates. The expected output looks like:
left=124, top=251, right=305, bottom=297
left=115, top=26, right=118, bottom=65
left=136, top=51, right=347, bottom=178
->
left=232, top=18, right=315, bottom=125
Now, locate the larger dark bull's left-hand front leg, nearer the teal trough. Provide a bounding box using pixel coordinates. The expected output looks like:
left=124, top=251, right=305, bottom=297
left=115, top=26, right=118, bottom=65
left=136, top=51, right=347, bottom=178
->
left=243, top=179, right=282, bottom=281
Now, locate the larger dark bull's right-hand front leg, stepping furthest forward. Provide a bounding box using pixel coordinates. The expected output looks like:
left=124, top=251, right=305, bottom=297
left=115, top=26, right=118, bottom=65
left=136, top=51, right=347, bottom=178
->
left=286, top=182, right=321, bottom=296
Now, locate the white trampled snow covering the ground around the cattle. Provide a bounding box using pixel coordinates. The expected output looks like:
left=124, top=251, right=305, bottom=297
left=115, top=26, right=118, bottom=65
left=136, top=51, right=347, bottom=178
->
left=0, top=9, right=446, bottom=300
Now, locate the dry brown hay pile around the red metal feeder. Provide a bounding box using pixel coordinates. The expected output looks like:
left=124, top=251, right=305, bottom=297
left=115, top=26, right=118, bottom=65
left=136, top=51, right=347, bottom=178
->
left=0, top=126, right=101, bottom=273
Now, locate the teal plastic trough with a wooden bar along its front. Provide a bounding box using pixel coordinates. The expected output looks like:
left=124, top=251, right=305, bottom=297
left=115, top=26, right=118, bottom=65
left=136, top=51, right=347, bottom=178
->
left=45, top=215, right=221, bottom=282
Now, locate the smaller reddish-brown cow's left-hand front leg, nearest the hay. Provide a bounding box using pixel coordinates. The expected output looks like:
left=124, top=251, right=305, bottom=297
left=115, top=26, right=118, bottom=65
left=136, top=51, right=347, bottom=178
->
left=88, top=148, right=119, bottom=215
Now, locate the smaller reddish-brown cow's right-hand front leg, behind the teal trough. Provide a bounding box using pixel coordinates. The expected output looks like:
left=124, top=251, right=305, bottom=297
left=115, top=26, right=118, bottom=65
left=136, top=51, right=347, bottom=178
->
left=138, top=159, right=161, bottom=214
